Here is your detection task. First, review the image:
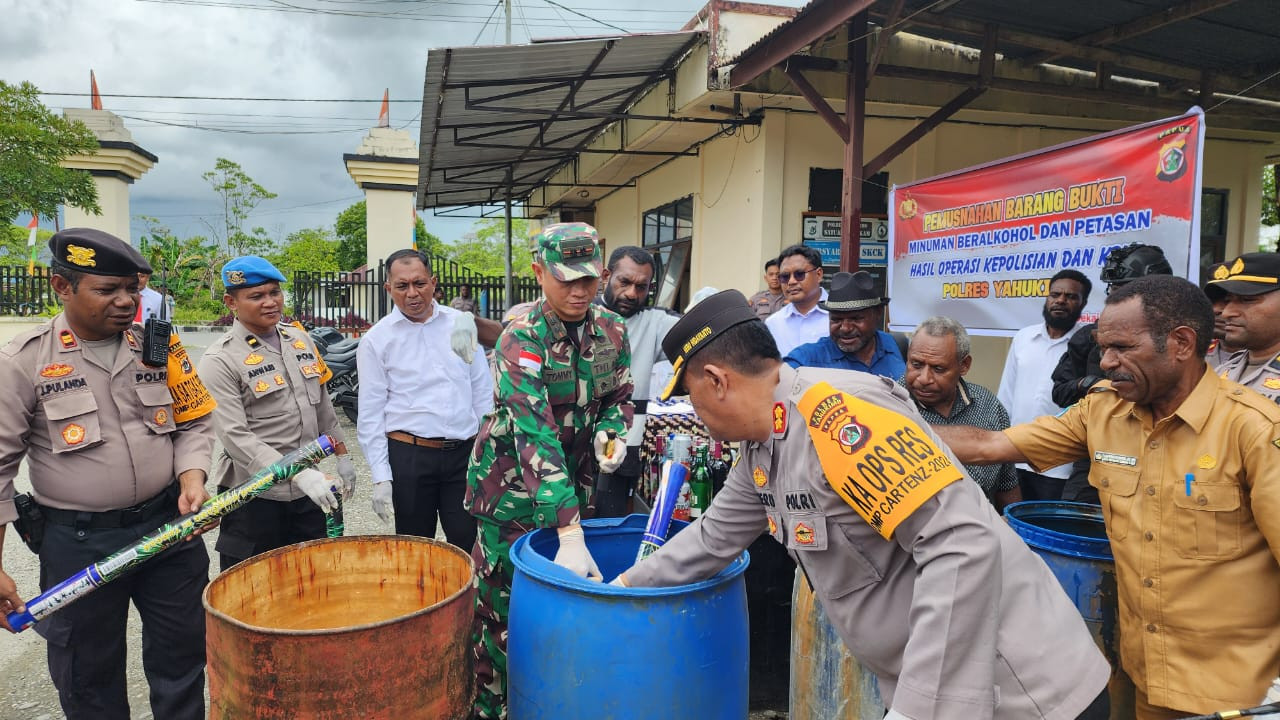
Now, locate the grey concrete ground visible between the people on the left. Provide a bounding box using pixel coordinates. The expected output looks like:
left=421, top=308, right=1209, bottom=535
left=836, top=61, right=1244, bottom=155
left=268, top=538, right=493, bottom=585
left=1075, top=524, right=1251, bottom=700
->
left=0, top=332, right=786, bottom=720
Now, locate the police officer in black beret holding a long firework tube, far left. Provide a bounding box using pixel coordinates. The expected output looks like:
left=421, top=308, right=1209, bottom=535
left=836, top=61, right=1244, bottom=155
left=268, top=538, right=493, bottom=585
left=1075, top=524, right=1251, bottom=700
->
left=0, top=228, right=212, bottom=720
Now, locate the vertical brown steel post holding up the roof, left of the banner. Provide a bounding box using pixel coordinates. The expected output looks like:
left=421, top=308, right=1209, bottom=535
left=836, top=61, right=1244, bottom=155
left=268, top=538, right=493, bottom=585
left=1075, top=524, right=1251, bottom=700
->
left=840, top=9, right=867, bottom=273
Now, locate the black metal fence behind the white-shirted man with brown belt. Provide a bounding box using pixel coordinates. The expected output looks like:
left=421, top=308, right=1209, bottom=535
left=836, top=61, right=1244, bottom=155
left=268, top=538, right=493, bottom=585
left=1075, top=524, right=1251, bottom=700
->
left=289, top=255, right=541, bottom=332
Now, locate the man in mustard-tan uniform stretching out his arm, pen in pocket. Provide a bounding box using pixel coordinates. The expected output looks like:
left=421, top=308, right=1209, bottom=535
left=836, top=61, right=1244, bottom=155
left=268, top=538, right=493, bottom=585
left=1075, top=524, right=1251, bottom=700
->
left=936, top=275, right=1280, bottom=720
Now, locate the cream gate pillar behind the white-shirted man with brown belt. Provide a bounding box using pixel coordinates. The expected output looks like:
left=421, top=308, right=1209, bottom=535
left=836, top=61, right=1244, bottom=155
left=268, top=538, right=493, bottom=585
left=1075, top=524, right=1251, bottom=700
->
left=342, top=128, right=417, bottom=268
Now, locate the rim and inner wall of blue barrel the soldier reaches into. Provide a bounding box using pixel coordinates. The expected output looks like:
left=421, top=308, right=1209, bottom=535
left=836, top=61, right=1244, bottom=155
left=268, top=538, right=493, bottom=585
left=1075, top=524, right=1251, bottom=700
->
left=511, top=515, right=751, bottom=597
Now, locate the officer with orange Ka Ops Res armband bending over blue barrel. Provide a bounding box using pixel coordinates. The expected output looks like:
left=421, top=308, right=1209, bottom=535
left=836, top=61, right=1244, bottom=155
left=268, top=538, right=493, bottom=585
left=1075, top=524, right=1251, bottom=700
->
left=613, top=291, right=1110, bottom=720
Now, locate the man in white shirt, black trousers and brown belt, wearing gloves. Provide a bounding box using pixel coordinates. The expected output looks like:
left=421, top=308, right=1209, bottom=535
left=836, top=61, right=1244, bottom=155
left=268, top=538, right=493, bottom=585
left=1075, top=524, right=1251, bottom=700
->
left=356, top=250, right=493, bottom=552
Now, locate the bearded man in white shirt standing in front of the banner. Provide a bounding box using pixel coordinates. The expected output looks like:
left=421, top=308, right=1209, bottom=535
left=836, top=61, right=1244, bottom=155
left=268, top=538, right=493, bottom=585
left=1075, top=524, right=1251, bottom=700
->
left=996, top=269, right=1093, bottom=500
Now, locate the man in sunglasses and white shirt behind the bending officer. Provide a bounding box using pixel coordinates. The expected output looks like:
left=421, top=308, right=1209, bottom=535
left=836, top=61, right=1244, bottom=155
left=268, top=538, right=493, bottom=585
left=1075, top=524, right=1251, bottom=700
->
left=764, top=245, right=831, bottom=357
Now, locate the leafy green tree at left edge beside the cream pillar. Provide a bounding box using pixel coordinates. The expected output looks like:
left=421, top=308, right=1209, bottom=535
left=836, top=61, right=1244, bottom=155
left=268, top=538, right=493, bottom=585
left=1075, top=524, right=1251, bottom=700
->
left=0, top=81, right=102, bottom=223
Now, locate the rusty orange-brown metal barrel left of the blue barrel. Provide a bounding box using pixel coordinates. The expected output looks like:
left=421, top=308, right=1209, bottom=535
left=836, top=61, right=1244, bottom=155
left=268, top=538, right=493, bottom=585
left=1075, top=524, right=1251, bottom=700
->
left=204, top=536, right=475, bottom=720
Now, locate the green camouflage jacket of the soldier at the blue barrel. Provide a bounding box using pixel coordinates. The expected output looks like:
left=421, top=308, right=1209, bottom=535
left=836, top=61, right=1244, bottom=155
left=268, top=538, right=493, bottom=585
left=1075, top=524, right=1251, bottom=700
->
left=465, top=300, right=632, bottom=528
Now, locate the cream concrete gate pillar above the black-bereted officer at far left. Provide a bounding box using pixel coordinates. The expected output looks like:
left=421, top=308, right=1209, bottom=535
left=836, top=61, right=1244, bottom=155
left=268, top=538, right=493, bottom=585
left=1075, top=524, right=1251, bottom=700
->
left=63, top=108, right=159, bottom=242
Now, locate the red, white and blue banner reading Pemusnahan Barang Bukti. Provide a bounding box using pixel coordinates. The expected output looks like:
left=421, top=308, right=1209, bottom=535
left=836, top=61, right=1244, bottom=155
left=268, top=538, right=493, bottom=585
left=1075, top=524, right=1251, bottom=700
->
left=888, top=108, right=1204, bottom=336
